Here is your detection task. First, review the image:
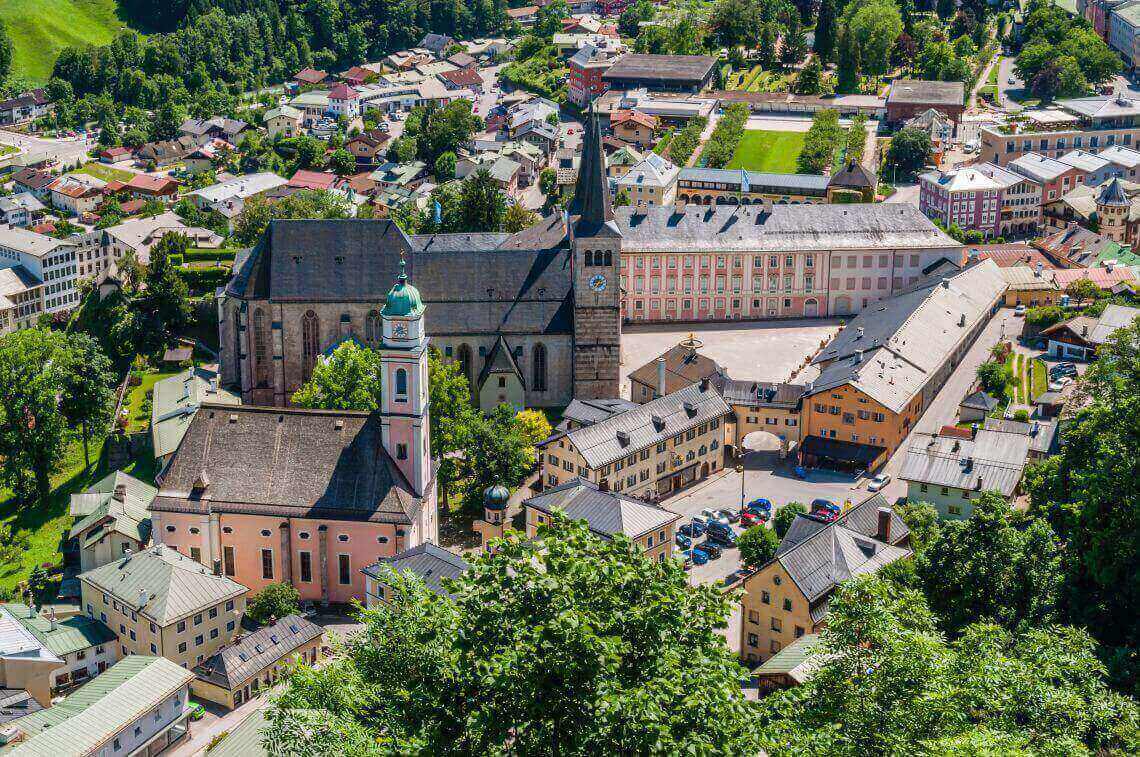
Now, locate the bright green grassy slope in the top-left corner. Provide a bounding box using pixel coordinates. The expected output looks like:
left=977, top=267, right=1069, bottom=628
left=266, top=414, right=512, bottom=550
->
left=0, top=0, right=141, bottom=83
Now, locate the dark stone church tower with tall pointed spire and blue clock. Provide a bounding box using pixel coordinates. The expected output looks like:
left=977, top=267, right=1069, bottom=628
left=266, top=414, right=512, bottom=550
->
left=569, top=105, right=621, bottom=399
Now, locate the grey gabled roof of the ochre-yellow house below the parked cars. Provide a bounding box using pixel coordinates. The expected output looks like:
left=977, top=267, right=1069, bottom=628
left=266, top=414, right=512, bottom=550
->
left=775, top=495, right=911, bottom=606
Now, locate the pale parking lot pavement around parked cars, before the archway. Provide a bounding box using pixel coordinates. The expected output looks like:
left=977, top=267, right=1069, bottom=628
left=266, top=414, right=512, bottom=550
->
left=660, top=451, right=870, bottom=584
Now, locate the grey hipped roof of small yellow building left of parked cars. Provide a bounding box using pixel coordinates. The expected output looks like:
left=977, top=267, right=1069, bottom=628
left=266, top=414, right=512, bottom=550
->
left=522, top=479, right=681, bottom=539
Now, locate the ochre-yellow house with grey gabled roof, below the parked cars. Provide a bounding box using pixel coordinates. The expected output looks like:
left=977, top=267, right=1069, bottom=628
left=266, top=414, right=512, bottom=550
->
left=740, top=495, right=911, bottom=662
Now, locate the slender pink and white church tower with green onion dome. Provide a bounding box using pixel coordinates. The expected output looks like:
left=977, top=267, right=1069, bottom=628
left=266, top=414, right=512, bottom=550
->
left=377, top=260, right=434, bottom=499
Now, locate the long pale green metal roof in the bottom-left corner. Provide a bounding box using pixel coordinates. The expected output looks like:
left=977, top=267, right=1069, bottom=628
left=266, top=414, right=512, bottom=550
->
left=7, top=654, right=194, bottom=757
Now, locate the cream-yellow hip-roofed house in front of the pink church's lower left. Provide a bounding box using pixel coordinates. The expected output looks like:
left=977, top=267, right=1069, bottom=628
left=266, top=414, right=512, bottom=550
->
left=79, top=544, right=246, bottom=668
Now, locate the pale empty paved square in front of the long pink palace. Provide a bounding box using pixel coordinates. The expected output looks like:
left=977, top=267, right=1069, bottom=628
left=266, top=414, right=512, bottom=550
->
left=621, top=318, right=839, bottom=398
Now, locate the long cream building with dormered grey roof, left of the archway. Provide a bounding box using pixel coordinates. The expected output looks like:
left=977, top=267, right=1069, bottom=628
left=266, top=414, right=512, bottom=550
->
left=539, top=380, right=728, bottom=500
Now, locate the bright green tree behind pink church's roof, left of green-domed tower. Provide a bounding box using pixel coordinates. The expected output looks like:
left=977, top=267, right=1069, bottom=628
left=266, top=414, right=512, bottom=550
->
left=292, top=341, right=382, bottom=410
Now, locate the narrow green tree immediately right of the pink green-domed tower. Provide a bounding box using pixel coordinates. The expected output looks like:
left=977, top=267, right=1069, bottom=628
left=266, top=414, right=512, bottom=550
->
left=428, top=349, right=479, bottom=510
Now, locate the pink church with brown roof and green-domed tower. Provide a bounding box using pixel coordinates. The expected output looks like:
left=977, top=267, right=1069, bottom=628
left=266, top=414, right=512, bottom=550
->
left=152, top=264, right=439, bottom=603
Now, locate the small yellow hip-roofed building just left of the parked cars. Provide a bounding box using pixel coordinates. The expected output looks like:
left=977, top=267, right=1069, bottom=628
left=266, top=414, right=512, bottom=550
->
left=522, top=479, right=681, bottom=561
